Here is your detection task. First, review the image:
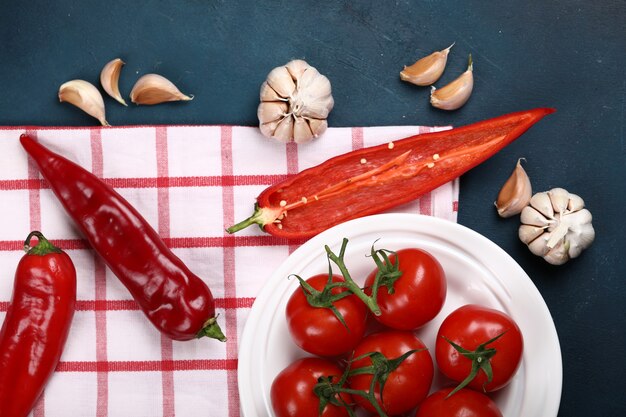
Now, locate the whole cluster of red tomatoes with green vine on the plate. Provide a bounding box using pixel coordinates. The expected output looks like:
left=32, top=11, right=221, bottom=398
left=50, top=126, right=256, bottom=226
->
left=271, top=241, right=523, bottom=417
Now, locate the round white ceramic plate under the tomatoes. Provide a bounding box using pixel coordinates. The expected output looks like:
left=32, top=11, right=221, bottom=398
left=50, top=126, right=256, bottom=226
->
left=238, top=214, right=563, bottom=417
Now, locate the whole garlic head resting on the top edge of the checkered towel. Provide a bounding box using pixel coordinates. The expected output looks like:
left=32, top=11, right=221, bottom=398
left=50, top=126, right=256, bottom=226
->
left=257, top=59, right=334, bottom=143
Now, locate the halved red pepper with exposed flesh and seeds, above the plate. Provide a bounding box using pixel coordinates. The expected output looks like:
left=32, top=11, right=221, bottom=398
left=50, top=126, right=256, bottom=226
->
left=227, top=108, right=554, bottom=239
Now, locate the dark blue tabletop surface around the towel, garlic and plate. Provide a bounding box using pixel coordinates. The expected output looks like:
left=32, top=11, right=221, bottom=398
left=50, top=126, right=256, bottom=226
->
left=0, top=0, right=626, bottom=417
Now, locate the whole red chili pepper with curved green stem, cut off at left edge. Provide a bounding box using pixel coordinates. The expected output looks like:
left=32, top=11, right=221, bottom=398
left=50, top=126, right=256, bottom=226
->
left=0, top=232, right=76, bottom=417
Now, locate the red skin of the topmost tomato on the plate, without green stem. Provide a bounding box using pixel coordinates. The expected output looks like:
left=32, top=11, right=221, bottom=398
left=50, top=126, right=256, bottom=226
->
left=365, top=248, right=447, bottom=330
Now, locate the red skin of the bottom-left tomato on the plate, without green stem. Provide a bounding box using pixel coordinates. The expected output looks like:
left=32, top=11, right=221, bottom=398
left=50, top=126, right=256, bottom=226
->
left=270, top=358, right=352, bottom=417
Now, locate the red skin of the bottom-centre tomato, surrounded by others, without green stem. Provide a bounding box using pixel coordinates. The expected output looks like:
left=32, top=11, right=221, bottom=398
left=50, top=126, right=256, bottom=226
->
left=348, top=330, right=434, bottom=416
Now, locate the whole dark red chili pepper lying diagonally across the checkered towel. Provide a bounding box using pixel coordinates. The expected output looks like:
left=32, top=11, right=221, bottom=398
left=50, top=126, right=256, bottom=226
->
left=20, top=135, right=226, bottom=341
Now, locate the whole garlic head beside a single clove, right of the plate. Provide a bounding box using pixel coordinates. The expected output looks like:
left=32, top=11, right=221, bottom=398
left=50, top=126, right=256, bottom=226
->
left=519, top=188, right=595, bottom=265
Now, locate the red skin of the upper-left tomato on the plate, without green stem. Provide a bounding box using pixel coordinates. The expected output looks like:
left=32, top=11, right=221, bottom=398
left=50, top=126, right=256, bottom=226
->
left=286, top=275, right=367, bottom=357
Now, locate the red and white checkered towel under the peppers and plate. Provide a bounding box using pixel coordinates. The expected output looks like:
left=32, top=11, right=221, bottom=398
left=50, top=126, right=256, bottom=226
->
left=0, top=126, right=458, bottom=417
